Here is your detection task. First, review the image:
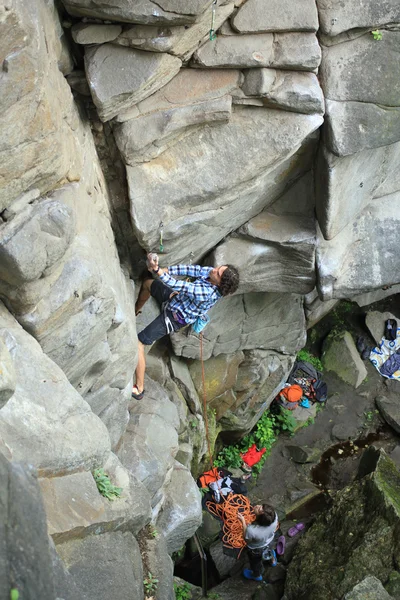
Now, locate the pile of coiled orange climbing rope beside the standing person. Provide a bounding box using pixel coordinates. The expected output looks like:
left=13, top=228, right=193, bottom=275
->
left=206, top=494, right=256, bottom=558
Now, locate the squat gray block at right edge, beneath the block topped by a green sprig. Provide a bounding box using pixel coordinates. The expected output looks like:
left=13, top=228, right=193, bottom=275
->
left=325, top=99, right=400, bottom=156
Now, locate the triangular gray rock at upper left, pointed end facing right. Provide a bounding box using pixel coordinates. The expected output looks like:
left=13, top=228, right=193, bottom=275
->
left=85, top=44, right=182, bottom=121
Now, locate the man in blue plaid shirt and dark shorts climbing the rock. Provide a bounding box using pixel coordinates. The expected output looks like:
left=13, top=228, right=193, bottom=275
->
left=132, top=253, right=239, bottom=400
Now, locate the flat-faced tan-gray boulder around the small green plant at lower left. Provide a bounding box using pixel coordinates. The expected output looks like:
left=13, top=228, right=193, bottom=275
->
left=39, top=455, right=151, bottom=544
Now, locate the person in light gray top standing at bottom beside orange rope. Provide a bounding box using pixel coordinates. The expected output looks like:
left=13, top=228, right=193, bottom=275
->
left=238, top=504, right=279, bottom=581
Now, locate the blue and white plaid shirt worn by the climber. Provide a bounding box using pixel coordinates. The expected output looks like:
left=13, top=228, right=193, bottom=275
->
left=160, top=265, right=222, bottom=323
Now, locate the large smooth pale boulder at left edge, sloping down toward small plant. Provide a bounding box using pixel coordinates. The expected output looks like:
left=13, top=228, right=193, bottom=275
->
left=0, top=305, right=110, bottom=475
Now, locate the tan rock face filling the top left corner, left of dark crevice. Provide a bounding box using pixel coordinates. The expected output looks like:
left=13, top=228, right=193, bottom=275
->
left=0, top=0, right=81, bottom=212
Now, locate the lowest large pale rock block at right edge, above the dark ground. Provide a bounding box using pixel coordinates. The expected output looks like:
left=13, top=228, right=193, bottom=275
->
left=316, top=193, right=400, bottom=300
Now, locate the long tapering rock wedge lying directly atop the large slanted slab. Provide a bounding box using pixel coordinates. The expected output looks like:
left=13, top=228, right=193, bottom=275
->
left=114, top=96, right=232, bottom=165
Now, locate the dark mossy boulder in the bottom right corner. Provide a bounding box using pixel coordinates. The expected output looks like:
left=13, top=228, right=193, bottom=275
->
left=285, top=450, right=400, bottom=600
